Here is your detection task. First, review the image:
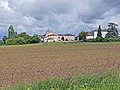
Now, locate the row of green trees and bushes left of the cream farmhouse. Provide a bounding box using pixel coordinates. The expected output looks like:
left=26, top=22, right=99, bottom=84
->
left=0, top=25, right=40, bottom=45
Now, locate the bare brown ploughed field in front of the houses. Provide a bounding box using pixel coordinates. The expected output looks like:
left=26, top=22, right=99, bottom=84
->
left=0, top=44, right=120, bottom=87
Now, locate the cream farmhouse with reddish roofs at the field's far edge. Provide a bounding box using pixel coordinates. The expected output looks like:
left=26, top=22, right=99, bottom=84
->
left=43, top=30, right=75, bottom=42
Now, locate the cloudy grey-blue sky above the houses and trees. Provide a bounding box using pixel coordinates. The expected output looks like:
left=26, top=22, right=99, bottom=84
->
left=0, top=0, right=120, bottom=37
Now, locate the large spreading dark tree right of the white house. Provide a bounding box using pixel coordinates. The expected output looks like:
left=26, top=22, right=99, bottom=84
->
left=105, top=22, right=119, bottom=38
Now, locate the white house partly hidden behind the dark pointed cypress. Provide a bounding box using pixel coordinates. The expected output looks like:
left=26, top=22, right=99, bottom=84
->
left=86, top=29, right=108, bottom=39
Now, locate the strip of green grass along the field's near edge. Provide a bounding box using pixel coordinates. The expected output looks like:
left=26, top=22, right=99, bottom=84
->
left=1, top=72, right=120, bottom=90
